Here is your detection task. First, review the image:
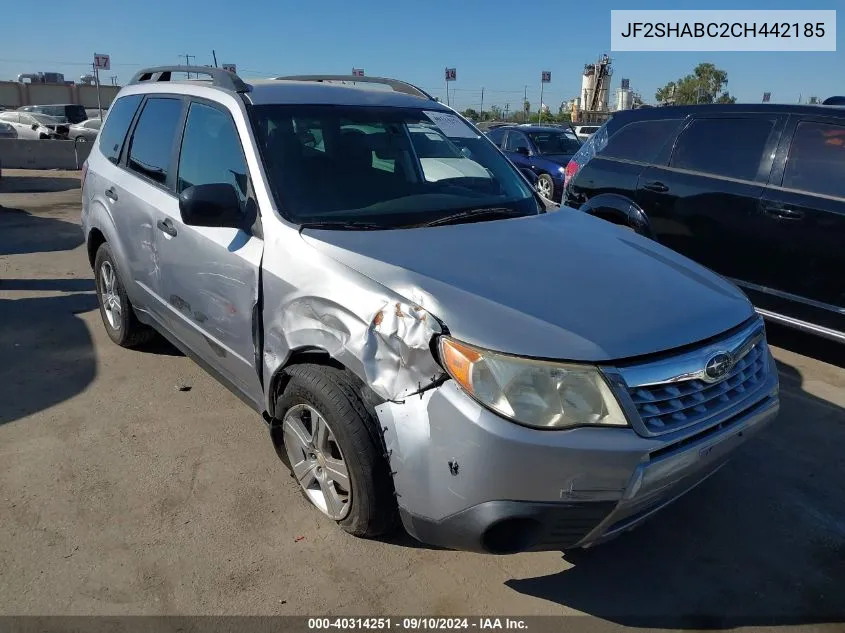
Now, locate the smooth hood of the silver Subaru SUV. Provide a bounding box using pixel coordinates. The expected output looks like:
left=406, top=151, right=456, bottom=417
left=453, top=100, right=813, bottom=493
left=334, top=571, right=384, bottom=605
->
left=302, top=209, right=754, bottom=362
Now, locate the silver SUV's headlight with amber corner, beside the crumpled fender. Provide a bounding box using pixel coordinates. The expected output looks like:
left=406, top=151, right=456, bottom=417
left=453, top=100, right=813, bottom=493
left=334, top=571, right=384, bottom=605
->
left=440, top=336, right=628, bottom=429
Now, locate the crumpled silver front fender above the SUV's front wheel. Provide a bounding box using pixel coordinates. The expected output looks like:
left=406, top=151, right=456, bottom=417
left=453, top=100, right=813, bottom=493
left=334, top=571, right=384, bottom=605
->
left=263, top=226, right=444, bottom=410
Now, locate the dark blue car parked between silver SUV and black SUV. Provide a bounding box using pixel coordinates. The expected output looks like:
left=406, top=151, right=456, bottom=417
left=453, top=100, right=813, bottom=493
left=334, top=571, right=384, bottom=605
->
left=487, top=125, right=581, bottom=202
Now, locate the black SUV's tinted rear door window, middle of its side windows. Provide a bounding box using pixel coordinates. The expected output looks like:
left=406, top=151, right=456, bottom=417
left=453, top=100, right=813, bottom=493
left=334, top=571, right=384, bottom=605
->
left=670, top=117, right=774, bottom=180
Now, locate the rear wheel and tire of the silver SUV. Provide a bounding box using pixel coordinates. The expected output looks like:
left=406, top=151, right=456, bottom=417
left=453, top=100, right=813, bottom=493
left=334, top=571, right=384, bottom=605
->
left=94, top=242, right=155, bottom=347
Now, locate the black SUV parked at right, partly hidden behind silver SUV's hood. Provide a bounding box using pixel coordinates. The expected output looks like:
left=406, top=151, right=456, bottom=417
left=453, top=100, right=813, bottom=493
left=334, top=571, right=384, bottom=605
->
left=563, top=104, right=845, bottom=342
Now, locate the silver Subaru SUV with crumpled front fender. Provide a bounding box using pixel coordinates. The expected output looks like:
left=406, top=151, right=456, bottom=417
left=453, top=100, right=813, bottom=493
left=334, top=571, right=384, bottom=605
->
left=82, top=67, right=778, bottom=553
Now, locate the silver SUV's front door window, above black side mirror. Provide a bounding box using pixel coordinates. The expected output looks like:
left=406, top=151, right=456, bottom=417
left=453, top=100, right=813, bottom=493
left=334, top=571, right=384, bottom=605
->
left=176, top=103, right=247, bottom=202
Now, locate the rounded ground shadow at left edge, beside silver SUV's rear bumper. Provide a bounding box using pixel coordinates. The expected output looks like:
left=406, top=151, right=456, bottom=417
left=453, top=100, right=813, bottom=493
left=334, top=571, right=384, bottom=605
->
left=0, top=207, right=84, bottom=255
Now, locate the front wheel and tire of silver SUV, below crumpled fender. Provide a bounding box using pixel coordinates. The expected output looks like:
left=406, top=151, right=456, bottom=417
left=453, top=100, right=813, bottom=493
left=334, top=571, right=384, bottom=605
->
left=272, top=365, right=397, bottom=538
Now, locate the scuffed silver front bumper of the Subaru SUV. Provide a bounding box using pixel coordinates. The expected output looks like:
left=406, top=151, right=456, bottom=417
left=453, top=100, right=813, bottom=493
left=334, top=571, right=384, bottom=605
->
left=378, top=360, right=779, bottom=554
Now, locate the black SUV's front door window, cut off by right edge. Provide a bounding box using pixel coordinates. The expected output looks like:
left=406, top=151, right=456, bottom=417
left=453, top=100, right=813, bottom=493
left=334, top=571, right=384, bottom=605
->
left=783, top=121, right=845, bottom=198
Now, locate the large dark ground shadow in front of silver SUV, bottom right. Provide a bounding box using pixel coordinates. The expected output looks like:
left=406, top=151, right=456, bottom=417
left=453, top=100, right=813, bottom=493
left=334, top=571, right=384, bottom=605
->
left=506, top=352, right=845, bottom=630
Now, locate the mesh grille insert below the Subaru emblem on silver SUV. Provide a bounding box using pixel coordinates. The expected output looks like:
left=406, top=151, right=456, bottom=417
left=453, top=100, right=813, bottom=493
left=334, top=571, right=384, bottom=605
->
left=628, top=338, right=769, bottom=433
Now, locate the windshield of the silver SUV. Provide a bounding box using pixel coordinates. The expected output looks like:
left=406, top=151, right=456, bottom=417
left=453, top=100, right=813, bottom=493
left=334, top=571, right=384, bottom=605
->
left=250, top=105, right=540, bottom=228
